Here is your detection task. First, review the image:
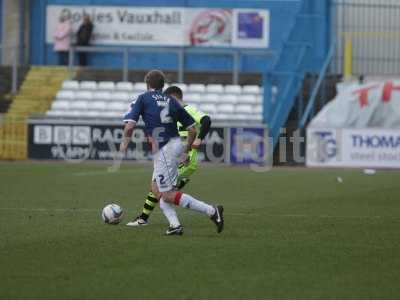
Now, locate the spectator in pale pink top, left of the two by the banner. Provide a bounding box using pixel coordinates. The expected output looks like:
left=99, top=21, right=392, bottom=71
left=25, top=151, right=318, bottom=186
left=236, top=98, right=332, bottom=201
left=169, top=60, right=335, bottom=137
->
left=53, top=16, right=72, bottom=66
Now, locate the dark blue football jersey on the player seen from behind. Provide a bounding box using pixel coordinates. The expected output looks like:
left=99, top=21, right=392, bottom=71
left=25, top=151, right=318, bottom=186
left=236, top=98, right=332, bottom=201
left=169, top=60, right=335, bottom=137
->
left=124, top=90, right=196, bottom=148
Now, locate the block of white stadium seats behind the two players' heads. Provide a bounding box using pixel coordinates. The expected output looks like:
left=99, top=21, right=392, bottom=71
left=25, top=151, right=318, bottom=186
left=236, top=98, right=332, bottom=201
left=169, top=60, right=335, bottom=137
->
left=47, top=80, right=263, bottom=123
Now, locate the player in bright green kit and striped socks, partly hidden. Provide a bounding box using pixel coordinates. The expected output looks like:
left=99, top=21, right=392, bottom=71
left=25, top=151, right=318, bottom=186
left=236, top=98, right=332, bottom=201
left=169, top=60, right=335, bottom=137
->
left=126, top=86, right=211, bottom=227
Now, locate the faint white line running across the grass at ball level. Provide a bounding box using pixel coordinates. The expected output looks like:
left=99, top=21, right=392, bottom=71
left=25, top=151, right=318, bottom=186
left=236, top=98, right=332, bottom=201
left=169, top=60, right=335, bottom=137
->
left=0, top=207, right=400, bottom=219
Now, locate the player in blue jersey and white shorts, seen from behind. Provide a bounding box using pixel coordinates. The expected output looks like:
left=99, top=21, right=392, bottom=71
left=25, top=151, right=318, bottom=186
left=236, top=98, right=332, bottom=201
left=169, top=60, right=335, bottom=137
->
left=120, top=70, right=224, bottom=235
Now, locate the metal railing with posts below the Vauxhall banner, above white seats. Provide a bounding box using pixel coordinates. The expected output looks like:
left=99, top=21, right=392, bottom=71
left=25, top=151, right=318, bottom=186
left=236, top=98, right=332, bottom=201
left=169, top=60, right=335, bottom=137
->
left=68, top=46, right=276, bottom=84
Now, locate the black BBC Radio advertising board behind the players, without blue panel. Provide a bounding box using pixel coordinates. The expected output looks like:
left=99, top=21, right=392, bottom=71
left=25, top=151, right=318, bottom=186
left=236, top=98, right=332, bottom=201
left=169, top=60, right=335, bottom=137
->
left=28, top=122, right=227, bottom=163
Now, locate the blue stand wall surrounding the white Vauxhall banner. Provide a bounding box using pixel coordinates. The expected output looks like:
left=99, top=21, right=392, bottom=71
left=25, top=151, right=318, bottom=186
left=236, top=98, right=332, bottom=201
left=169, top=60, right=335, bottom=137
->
left=27, top=0, right=328, bottom=73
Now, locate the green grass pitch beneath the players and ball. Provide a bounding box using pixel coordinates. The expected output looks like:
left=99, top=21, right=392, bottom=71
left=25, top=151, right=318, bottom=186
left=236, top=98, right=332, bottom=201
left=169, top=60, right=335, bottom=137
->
left=0, top=163, right=400, bottom=300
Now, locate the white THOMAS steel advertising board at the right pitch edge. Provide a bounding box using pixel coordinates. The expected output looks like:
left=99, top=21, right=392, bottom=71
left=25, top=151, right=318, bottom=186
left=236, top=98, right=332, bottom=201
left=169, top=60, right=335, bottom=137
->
left=307, top=128, right=400, bottom=168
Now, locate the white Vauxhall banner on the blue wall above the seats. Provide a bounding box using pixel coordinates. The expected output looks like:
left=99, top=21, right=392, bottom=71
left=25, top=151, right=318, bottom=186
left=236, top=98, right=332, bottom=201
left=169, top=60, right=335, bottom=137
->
left=46, top=5, right=270, bottom=48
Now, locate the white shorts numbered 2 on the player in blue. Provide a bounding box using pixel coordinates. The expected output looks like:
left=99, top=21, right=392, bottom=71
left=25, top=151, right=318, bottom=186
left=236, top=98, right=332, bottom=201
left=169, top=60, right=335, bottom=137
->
left=153, top=138, right=183, bottom=192
